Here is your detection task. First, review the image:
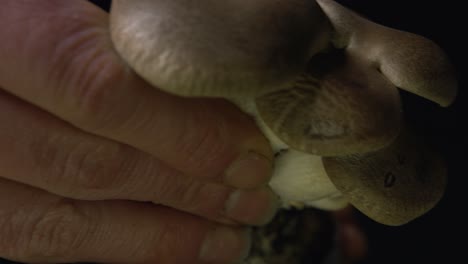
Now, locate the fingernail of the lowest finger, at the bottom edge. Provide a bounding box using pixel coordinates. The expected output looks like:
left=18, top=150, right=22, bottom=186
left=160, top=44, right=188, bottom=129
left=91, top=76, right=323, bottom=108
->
left=200, top=226, right=252, bottom=263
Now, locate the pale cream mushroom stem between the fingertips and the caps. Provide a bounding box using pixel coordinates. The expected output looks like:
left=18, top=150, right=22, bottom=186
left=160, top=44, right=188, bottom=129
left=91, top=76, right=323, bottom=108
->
left=230, top=98, right=348, bottom=210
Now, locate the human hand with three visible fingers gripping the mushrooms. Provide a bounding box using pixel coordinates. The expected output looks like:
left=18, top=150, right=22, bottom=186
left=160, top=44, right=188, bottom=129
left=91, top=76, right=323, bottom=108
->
left=0, top=0, right=276, bottom=263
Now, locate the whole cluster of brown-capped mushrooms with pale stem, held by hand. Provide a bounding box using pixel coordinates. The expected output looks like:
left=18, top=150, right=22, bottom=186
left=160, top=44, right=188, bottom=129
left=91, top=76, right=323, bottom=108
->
left=111, top=0, right=457, bottom=225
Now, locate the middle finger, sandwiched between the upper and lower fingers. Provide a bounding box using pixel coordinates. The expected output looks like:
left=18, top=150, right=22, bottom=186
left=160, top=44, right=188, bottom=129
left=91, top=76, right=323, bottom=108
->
left=0, top=90, right=277, bottom=225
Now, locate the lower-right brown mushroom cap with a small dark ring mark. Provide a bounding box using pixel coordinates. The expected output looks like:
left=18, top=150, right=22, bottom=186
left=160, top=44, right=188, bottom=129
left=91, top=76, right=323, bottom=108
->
left=323, top=130, right=447, bottom=225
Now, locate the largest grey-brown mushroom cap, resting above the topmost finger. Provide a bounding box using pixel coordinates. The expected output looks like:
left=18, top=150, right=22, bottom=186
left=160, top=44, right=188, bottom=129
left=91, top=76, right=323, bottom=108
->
left=110, top=0, right=331, bottom=97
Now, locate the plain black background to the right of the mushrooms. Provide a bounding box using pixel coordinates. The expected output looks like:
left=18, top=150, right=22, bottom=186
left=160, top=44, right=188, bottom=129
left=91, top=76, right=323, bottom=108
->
left=0, top=0, right=468, bottom=264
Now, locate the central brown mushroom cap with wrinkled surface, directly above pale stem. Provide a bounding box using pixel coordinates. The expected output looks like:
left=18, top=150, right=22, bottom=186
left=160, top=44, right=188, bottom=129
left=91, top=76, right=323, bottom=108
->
left=256, top=50, right=402, bottom=156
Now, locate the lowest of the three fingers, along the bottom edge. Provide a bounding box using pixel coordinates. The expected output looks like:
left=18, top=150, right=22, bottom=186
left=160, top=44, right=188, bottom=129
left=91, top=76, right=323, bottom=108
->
left=0, top=179, right=250, bottom=263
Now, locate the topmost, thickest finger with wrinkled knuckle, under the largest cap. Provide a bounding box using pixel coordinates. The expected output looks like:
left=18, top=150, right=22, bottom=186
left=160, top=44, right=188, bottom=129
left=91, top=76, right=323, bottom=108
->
left=0, top=0, right=272, bottom=188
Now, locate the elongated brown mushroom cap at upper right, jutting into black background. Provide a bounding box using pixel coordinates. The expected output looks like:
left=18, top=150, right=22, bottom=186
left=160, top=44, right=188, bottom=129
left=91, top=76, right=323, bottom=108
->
left=317, top=0, right=457, bottom=106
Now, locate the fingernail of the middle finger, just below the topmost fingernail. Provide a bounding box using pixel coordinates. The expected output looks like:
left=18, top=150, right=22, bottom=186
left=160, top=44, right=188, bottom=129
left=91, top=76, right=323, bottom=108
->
left=225, top=187, right=279, bottom=225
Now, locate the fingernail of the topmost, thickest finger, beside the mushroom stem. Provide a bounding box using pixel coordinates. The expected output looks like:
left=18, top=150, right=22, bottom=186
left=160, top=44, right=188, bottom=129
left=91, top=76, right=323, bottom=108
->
left=224, top=151, right=273, bottom=189
